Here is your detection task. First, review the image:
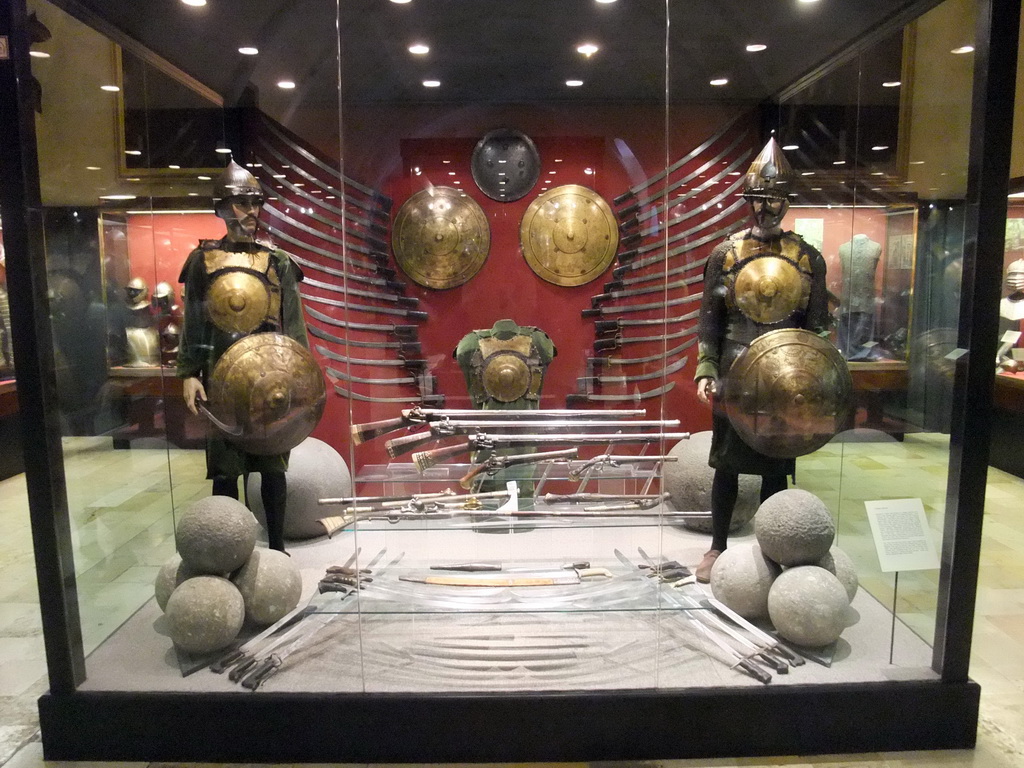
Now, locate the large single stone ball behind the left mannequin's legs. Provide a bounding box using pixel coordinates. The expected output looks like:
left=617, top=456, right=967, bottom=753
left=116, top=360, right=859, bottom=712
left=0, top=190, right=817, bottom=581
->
left=246, top=437, right=352, bottom=540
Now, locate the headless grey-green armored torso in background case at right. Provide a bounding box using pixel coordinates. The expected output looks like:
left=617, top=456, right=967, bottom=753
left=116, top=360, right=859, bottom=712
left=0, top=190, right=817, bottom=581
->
left=838, top=234, right=882, bottom=359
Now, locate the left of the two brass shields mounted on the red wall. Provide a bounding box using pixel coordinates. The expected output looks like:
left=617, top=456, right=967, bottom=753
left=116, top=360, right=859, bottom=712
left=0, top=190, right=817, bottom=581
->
left=391, top=186, right=490, bottom=290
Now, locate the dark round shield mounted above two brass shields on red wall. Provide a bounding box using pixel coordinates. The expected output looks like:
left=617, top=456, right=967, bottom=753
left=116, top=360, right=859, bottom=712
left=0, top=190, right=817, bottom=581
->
left=470, top=128, right=541, bottom=203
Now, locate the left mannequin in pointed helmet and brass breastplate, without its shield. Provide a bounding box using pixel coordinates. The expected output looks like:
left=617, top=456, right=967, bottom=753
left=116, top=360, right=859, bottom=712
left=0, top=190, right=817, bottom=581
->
left=177, top=161, right=309, bottom=551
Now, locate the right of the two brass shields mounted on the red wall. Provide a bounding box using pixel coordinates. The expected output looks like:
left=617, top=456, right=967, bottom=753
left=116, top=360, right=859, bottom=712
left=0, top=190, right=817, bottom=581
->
left=519, top=184, right=618, bottom=286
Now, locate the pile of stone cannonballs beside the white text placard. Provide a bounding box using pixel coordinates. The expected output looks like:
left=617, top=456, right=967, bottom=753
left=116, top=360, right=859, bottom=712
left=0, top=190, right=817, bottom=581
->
left=711, top=488, right=857, bottom=647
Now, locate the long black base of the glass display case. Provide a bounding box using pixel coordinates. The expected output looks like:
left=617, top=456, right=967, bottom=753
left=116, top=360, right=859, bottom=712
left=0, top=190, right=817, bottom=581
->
left=39, top=681, right=981, bottom=763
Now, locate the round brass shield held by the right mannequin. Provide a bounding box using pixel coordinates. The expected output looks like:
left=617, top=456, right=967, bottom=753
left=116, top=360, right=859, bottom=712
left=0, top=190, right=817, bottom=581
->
left=719, top=329, right=853, bottom=458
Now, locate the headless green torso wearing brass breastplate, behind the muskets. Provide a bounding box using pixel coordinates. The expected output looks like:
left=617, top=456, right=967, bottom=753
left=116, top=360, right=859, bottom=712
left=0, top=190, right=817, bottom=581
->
left=454, top=319, right=558, bottom=497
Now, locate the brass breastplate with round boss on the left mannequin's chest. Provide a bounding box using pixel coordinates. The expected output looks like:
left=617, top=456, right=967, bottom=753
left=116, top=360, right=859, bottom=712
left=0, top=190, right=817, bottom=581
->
left=204, top=248, right=282, bottom=335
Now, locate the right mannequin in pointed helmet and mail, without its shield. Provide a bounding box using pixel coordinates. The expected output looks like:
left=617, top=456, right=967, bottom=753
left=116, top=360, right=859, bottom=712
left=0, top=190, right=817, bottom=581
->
left=693, top=139, right=828, bottom=583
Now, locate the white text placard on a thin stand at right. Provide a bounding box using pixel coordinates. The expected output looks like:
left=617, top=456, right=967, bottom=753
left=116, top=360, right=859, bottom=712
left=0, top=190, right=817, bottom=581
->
left=864, top=499, right=939, bottom=573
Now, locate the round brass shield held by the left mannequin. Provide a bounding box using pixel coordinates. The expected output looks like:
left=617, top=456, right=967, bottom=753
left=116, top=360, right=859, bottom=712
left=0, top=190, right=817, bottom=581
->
left=206, top=334, right=327, bottom=456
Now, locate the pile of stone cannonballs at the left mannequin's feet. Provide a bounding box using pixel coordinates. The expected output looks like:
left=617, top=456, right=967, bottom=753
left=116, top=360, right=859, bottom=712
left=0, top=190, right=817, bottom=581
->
left=156, top=496, right=302, bottom=653
